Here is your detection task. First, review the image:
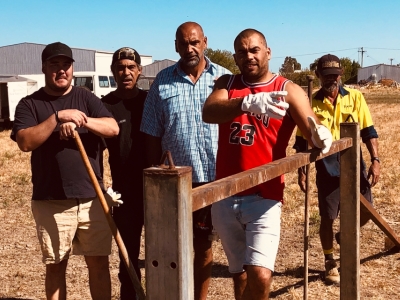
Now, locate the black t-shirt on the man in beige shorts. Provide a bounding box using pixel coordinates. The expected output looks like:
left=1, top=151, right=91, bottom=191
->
left=11, top=87, right=112, bottom=200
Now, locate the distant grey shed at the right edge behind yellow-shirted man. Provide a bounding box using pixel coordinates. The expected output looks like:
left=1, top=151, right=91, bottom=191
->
left=357, top=64, right=400, bottom=82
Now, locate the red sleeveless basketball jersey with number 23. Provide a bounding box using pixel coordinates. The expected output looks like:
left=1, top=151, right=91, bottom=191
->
left=216, top=75, right=296, bottom=201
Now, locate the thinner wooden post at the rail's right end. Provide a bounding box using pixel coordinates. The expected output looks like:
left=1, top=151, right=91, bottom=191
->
left=340, top=123, right=360, bottom=300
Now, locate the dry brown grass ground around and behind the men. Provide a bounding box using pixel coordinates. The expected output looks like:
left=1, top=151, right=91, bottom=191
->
left=0, top=89, right=400, bottom=300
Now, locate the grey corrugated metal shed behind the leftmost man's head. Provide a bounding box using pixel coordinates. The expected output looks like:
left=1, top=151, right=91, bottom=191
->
left=0, top=43, right=104, bottom=75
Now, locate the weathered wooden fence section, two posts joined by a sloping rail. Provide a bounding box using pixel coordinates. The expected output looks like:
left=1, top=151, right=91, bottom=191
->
left=143, top=123, right=360, bottom=300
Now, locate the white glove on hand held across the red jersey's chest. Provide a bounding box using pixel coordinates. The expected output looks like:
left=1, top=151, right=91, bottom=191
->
left=242, top=91, right=289, bottom=120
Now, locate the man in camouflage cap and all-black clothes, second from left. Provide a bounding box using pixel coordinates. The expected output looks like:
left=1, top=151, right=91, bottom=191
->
left=102, top=47, right=147, bottom=300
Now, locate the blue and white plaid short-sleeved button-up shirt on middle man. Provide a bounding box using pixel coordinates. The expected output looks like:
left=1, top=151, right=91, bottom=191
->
left=140, top=57, right=230, bottom=182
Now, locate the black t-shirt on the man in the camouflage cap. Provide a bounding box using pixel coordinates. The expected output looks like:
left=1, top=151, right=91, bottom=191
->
left=101, top=90, right=147, bottom=205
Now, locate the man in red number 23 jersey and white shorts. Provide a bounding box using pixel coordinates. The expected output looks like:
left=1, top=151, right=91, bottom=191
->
left=203, top=29, right=332, bottom=300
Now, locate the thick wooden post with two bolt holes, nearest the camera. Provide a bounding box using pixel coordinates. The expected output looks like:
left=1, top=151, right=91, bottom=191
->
left=143, top=165, right=194, bottom=300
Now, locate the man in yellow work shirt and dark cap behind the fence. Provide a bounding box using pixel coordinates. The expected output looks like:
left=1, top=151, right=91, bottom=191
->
left=294, top=54, right=380, bottom=284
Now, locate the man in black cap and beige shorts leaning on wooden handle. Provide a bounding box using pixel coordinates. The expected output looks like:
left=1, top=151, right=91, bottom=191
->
left=11, top=42, right=119, bottom=299
